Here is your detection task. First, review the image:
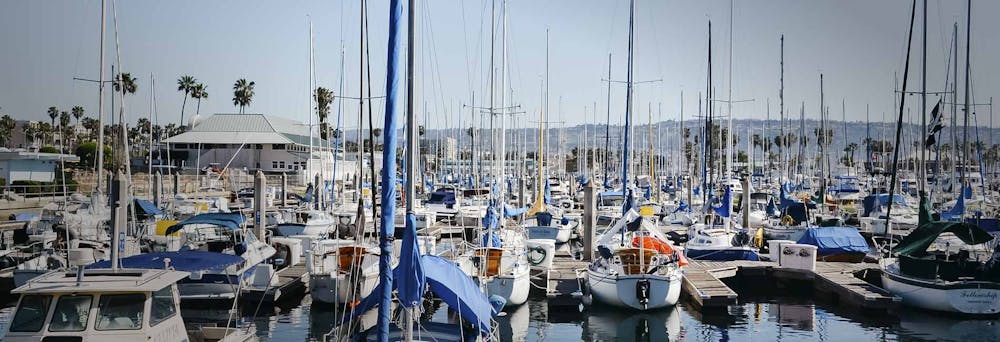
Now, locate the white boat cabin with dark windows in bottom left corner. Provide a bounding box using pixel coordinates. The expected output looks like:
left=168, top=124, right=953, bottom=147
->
left=4, top=269, right=188, bottom=342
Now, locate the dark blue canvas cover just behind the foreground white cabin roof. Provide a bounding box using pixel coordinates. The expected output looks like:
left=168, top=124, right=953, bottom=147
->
left=86, top=251, right=244, bottom=272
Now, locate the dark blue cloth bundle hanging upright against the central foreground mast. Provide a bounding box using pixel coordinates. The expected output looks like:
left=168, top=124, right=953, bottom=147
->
left=393, top=213, right=427, bottom=307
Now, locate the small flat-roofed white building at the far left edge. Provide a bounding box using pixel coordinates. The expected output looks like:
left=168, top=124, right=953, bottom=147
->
left=0, top=149, right=80, bottom=184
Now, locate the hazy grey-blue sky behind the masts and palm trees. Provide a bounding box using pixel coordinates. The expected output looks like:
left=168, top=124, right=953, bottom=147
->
left=0, top=0, right=1000, bottom=131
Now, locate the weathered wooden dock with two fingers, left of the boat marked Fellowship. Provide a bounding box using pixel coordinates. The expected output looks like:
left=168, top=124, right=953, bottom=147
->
left=683, top=261, right=900, bottom=310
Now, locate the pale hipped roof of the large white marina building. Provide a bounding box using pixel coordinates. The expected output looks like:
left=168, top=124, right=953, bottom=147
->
left=164, top=114, right=328, bottom=146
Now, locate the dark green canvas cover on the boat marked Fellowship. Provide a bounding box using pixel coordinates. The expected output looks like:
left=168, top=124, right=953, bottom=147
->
left=892, top=193, right=993, bottom=257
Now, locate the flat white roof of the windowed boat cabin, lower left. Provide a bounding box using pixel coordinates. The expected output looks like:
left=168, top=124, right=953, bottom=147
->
left=11, top=269, right=188, bottom=294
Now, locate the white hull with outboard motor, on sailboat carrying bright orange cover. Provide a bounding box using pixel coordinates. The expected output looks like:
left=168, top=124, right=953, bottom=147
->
left=587, top=269, right=681, bottom=310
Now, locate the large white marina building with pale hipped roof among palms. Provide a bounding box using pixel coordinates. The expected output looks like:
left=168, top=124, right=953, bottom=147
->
left=163, top=114, right=354, bottom=184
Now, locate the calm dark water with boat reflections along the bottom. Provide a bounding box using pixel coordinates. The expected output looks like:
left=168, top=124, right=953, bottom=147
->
left=7, top=293, right=1000, bottom=342
